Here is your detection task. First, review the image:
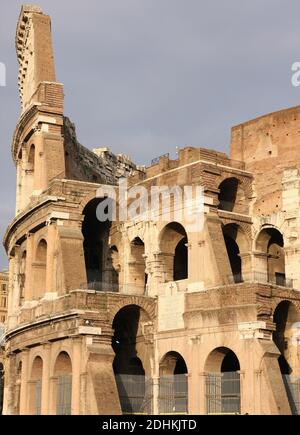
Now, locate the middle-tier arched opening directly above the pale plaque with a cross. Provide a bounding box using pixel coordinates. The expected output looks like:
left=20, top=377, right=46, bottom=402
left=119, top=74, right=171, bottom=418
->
left=160, top=222, right=188, bottom=282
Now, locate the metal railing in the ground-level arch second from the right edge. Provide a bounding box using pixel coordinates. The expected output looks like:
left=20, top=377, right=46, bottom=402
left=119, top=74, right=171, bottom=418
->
left=206, top=372, right=241, bottom=414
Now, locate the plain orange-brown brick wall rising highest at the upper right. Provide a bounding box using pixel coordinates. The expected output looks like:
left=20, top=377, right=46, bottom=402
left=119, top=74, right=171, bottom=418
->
left=230, top=106, right=300, bottom=216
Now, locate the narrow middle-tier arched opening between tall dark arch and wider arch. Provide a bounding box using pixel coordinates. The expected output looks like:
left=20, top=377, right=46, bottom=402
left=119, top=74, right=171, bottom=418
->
left=128, top=237, right=148, bottom=294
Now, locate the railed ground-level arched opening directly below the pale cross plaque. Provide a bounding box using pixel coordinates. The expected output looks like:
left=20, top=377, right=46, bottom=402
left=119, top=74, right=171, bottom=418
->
left=159, top=352, right=188, bottom=414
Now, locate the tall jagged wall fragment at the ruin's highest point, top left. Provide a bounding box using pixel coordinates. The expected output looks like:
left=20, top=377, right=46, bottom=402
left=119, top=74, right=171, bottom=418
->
left=16, top=5, right=56, bottom=111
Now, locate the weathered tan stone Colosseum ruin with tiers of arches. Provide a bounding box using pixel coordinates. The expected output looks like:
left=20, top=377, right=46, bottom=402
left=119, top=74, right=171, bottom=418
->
left=3, top=5, right=300, bottom=415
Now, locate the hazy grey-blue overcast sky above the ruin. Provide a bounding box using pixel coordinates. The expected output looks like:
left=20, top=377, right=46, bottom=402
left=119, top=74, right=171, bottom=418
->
left=0, top=0, right=300, bottom=269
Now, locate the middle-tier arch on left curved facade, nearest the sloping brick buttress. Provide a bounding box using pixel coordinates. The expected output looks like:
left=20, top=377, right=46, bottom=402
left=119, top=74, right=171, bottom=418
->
left=33, top=239, right=47, bottom=299
